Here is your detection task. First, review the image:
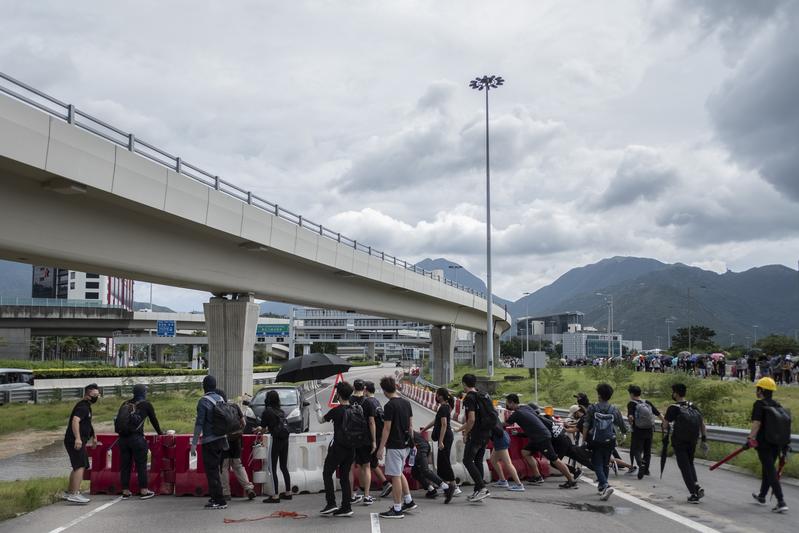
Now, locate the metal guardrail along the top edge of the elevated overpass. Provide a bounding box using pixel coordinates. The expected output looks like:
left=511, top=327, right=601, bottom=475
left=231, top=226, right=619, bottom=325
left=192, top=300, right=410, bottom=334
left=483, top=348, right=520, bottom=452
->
left=0, top=72, right=485, bottom=298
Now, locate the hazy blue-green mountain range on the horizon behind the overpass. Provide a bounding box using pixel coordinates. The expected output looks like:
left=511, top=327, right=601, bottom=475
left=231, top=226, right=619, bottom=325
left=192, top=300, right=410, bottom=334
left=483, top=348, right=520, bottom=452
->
left=0, top=257, right=799, bottom=348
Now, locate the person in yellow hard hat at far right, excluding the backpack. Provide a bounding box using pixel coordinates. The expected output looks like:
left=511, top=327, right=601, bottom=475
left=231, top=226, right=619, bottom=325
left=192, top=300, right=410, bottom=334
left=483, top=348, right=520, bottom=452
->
left=746, top=377, right=788, bottom=513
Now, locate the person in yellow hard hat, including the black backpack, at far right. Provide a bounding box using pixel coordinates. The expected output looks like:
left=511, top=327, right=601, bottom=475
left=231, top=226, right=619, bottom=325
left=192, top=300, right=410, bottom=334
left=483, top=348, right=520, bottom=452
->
left=745, top=378, right=791, bottom=513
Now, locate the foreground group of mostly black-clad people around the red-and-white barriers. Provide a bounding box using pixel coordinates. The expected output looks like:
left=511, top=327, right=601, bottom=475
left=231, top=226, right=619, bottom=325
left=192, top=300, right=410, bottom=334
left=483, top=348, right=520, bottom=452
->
left=59, top=374, right=791, bottom=519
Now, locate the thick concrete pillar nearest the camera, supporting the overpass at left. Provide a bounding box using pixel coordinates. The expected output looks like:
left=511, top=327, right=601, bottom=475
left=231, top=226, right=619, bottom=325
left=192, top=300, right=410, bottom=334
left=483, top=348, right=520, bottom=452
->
left=203, top=295, right=260, bottom=398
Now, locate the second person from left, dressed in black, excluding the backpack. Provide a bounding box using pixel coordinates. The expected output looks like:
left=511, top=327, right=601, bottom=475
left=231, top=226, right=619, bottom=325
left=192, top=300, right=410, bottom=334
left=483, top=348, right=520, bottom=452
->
left=117, top=383, right=163, bottom=500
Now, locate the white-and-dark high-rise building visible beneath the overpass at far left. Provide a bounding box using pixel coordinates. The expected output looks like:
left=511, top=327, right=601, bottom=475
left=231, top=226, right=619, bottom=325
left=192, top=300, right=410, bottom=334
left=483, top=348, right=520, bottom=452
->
left=32, top=266, right=133, bottom=311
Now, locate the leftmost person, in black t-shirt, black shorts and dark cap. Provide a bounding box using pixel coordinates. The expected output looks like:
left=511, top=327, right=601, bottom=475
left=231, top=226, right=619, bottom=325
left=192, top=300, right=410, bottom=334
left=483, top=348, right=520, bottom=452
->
left=64, top=383, right=100, bottom=505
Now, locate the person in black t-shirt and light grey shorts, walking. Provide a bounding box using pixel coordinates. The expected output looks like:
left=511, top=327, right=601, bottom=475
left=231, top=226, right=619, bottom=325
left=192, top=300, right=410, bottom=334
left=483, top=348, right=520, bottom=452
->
left=377, top=376, right=418, bottom=518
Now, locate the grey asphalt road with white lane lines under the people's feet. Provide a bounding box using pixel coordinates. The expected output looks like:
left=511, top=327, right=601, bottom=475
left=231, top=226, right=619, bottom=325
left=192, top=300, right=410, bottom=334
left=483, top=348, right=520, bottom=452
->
left=0, top=367, right=799, bottom=533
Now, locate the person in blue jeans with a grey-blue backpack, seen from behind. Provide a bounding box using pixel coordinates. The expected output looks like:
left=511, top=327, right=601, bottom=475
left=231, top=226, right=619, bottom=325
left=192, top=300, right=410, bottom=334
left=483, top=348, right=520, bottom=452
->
left=583, top=383, right=627, bottom=501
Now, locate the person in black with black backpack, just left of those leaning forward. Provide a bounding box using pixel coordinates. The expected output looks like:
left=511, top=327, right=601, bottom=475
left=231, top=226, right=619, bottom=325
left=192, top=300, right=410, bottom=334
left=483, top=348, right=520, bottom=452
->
left=461, top=374, right=490, bottom=502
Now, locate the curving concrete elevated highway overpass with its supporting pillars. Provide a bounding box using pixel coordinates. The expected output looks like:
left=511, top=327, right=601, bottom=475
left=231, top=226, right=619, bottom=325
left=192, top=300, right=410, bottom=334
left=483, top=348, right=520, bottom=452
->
left=0, top=74, right=511, bottom=395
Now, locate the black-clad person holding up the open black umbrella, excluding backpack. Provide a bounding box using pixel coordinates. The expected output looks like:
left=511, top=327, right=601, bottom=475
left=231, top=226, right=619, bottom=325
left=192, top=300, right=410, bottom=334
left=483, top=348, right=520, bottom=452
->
left=316, top=381, right=355, bottom=516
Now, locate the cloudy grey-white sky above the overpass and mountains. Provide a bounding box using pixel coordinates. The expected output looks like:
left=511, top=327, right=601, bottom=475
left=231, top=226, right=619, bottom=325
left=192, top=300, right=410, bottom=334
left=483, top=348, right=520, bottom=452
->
left=0, top=0, right=799, bottom=309
